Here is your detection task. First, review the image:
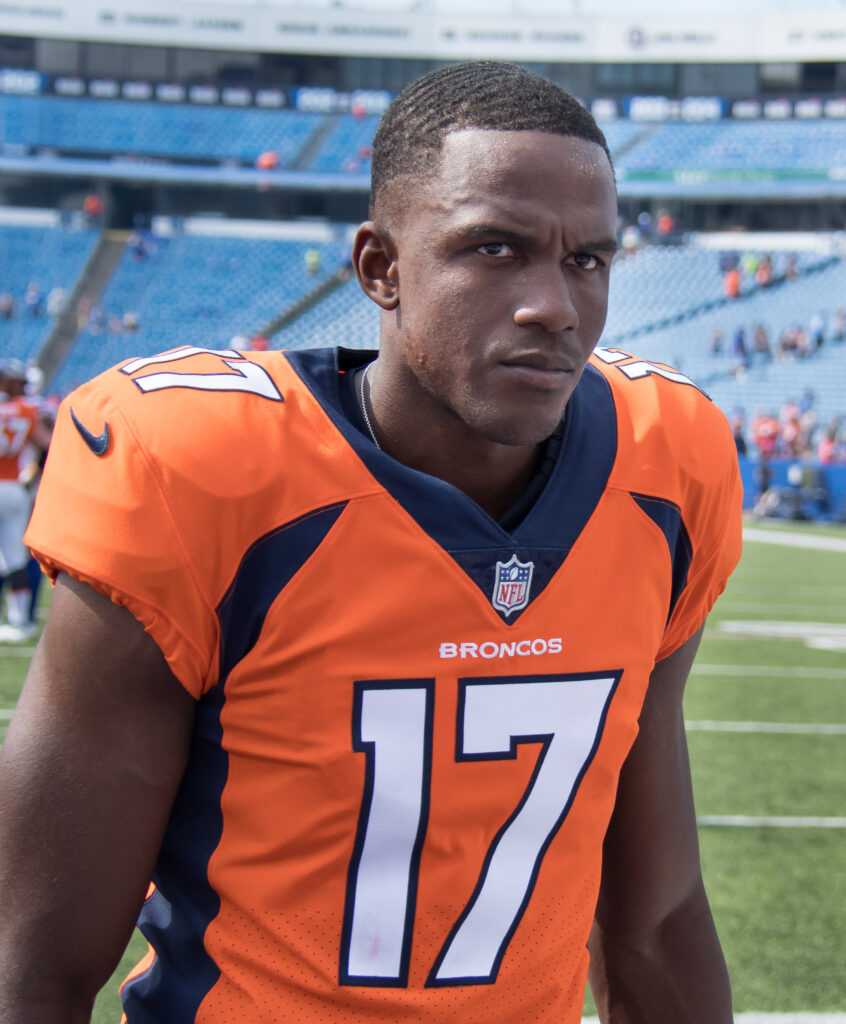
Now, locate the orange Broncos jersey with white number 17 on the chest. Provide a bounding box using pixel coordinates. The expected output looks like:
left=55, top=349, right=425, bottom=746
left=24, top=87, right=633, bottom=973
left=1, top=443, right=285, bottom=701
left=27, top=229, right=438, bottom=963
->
left=27, top=348, right=741, bottom=1024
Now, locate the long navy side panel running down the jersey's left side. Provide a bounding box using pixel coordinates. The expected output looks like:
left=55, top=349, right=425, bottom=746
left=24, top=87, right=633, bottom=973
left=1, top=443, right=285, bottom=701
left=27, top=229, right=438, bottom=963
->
left=122, top=502, right=346, bottom=1024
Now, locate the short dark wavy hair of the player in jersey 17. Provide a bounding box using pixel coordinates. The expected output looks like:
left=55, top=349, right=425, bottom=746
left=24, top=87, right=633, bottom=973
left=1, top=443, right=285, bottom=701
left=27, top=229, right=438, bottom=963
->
left=370, top=60, right=614, bottom=216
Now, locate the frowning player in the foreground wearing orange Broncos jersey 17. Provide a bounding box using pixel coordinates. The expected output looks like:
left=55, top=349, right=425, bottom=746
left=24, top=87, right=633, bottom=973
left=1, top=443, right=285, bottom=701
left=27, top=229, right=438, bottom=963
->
left=0, top=61, right=741, bottom=1024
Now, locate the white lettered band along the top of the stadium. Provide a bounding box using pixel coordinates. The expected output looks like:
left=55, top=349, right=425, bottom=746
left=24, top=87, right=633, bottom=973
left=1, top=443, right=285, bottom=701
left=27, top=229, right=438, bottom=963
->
left=3, top=0, right=846, bottom=62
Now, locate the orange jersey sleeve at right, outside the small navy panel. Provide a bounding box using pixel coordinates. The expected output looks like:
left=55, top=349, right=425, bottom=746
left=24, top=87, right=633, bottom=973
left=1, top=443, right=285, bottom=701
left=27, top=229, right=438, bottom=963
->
left=657, top=409, right=743, bottom=660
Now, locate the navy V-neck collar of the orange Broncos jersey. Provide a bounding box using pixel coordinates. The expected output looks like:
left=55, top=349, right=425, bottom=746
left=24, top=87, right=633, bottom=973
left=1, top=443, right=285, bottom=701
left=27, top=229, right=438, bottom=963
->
left=286, top=349, right=617, bottom=625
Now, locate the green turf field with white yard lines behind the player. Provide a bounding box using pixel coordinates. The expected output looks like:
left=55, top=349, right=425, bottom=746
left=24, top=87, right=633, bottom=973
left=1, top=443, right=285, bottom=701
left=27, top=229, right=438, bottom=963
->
left=0, top=523, right=846, bottom=1024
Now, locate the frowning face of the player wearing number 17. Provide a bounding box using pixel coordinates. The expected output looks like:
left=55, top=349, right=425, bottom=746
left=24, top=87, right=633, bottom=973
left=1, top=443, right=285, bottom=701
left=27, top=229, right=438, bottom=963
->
left=382, top=129, right=617, bottom=445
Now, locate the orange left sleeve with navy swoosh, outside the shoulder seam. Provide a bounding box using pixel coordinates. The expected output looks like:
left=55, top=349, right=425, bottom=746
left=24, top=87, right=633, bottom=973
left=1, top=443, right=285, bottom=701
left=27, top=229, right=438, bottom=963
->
left=25, top=378, right=217, bottom=697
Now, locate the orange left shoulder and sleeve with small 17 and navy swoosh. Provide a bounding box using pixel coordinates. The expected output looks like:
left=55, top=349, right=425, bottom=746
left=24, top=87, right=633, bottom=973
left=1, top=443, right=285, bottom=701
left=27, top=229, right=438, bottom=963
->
left=28, top=348, right=375, bottom=694
